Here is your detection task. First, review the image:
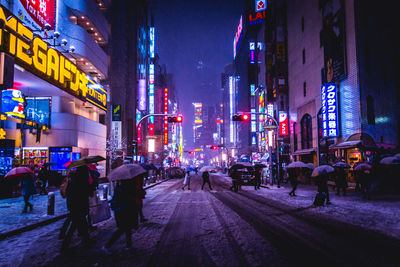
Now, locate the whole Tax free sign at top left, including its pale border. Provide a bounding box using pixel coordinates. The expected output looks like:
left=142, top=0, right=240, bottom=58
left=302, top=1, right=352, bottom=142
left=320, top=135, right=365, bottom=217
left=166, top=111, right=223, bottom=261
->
left=14, top=0, right=56, bottom=30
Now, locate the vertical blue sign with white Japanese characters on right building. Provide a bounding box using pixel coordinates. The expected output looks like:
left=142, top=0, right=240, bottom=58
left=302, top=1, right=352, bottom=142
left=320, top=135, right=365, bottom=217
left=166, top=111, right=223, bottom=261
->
left=321, top=84, right=339, bottom=137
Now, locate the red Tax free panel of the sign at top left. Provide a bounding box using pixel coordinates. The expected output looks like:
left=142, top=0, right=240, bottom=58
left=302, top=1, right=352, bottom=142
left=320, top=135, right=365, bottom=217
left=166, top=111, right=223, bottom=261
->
left=19, top=0, right=56, bottom=30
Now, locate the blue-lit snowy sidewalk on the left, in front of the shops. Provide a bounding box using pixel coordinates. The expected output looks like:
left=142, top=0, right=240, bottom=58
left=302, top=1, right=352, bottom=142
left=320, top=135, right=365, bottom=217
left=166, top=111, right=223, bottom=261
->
left=0, top=179, right=169, bottom=240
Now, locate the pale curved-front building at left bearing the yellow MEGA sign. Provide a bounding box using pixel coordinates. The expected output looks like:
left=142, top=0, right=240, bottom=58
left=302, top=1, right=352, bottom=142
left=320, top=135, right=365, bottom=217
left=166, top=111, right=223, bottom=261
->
left=0, top=0, right=109, bottom=177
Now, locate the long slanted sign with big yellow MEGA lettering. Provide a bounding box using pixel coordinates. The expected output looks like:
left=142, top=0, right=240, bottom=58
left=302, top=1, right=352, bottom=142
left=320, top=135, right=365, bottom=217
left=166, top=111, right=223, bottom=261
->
left=0, top=6, right=107, bottom=110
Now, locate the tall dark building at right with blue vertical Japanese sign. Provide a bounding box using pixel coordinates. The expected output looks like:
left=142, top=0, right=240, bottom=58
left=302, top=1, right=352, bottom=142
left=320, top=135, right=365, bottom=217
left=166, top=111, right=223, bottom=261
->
left=287, top=0, right=400, bottom=168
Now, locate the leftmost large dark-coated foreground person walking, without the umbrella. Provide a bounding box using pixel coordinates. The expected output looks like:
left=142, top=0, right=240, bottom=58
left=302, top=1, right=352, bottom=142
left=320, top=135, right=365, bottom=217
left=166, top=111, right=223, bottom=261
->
left=61, top=165, right=91, bottom=250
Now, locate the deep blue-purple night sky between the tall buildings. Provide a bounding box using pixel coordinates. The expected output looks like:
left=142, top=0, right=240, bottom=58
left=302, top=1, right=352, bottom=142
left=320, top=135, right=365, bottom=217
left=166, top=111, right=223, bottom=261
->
left=152, top=0, right=245, bottom=148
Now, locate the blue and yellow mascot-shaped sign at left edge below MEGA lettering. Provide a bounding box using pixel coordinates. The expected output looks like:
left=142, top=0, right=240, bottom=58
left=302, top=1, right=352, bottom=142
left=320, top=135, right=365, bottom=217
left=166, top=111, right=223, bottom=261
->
left=1, top=89, right=25, bottom=119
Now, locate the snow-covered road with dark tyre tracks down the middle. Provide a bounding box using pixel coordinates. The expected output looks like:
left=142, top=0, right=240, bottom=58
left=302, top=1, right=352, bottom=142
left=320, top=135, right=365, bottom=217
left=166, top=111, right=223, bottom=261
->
left=0, top=176, right=400, bottom=267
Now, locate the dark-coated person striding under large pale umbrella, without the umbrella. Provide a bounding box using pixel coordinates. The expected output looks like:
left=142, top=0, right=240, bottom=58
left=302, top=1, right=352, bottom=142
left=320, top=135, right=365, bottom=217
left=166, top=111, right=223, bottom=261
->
left=102, top=179, right=138, bottom=254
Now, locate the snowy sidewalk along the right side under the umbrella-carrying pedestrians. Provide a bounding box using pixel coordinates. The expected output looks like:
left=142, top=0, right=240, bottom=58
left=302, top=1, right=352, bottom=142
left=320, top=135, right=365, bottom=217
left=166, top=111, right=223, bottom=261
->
left=219, top=177, right=400, bottom=239
